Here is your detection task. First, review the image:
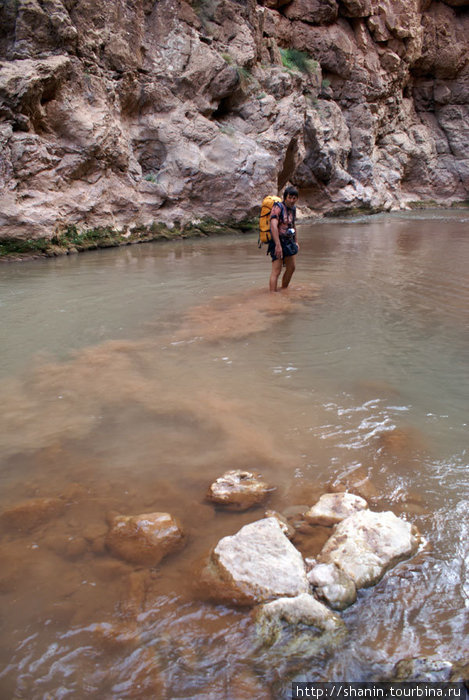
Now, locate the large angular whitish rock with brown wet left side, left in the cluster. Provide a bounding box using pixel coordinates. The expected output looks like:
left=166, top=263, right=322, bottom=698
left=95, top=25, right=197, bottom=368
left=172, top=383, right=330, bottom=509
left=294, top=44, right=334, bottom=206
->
left=198, top=518, right=309, bottom=605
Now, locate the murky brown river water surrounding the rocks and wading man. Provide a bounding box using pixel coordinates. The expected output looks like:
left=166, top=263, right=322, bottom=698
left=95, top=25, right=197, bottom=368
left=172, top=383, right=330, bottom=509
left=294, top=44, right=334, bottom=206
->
left=0, top=211, right=469, bottom=700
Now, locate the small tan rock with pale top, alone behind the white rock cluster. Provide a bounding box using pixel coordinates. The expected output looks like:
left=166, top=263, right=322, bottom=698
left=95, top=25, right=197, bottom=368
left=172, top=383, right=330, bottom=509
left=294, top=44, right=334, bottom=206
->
left=207, top=469, right=273, bottom=510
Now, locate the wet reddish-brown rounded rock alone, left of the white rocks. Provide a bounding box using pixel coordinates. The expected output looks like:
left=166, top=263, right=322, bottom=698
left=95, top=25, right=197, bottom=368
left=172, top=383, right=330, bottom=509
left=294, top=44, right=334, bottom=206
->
left=106, top=513, right=184, bottom=566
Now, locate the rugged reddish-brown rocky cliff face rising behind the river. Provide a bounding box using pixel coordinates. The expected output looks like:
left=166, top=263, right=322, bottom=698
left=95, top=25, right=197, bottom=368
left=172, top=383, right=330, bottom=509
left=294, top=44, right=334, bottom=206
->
left=0, top=0, right=469, bottom=237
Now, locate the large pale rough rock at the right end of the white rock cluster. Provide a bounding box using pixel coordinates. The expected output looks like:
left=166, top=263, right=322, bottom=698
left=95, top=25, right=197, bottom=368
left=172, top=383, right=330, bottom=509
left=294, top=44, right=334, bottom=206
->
left=319, top=510, right=419, bottom=588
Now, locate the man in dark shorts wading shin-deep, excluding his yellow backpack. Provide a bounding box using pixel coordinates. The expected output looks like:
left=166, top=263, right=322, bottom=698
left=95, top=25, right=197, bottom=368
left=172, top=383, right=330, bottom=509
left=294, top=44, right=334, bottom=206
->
left=267, top=187, right=299, bottom=292
